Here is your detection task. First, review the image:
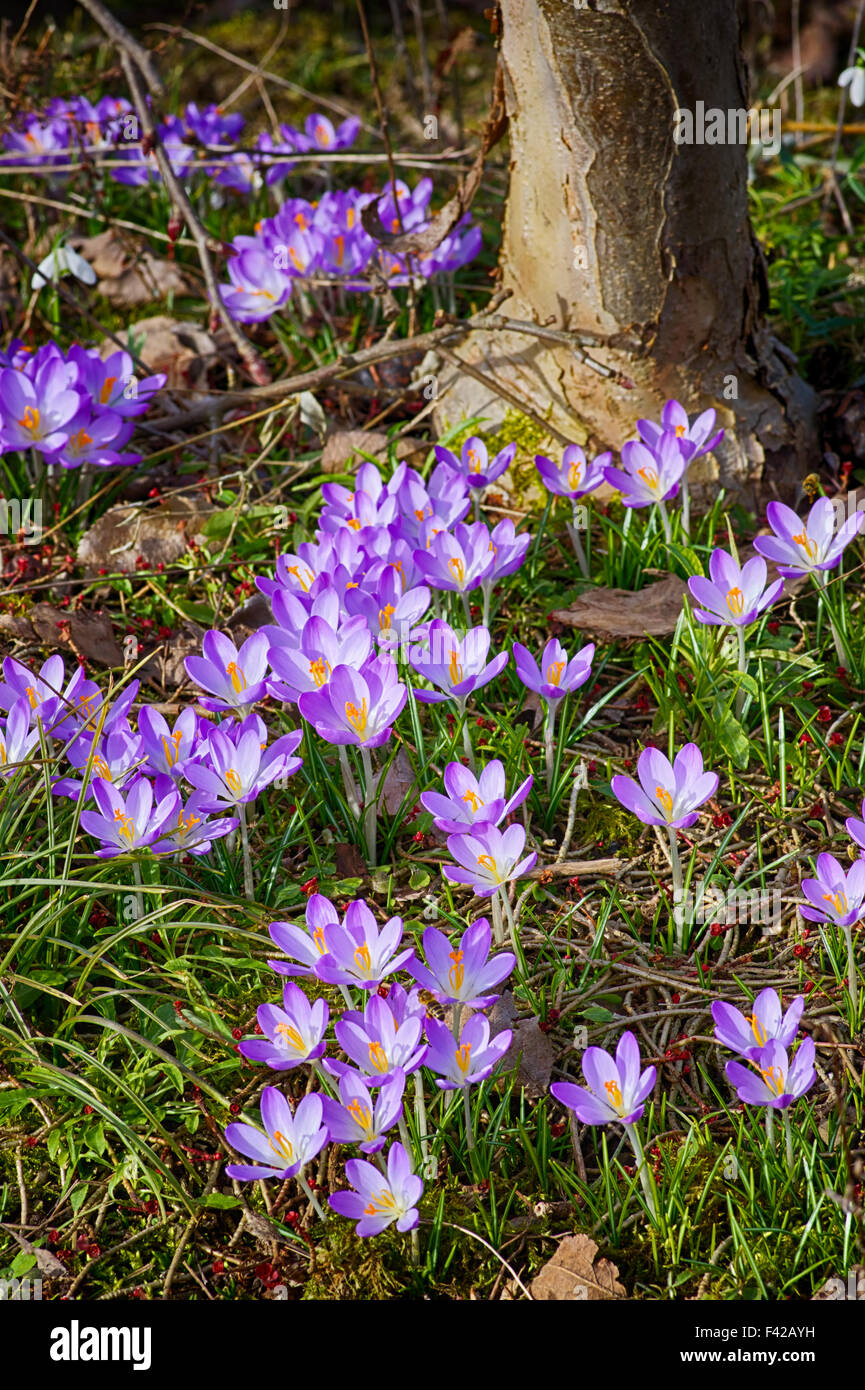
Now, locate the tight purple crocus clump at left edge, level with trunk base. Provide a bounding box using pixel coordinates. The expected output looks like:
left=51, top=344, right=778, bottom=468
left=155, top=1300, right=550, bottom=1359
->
left=0, top=339, right=165, bottom=468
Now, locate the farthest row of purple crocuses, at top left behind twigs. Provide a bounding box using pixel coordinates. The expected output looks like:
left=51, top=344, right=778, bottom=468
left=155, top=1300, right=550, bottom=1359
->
left=0, top=96, right=360, bottom=193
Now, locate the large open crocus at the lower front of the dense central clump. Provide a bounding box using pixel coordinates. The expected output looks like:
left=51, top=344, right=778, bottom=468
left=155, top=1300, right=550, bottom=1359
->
left=298, top=656, right=409, bottom=748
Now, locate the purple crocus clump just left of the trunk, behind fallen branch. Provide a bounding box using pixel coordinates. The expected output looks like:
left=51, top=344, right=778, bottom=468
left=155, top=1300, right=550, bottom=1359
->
left=223, top=178, right=481, bottom=322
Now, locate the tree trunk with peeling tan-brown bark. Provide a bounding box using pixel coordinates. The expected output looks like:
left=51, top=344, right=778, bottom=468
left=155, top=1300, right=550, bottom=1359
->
left=439, top=0, right=816, bottom=503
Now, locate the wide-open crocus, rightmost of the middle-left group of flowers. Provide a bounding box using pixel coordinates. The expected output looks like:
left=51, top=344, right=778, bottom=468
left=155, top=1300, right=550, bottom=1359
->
left=182, top=714, right=303, bottom=810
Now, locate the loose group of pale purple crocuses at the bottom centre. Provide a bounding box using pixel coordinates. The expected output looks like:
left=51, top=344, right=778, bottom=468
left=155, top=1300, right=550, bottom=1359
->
left=225, top=894, right=516, bottom=1236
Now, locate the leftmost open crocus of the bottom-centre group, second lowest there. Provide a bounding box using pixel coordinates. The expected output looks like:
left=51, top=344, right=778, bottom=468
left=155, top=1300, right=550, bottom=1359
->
left=225, top=1086, right=327, bottom=1183
